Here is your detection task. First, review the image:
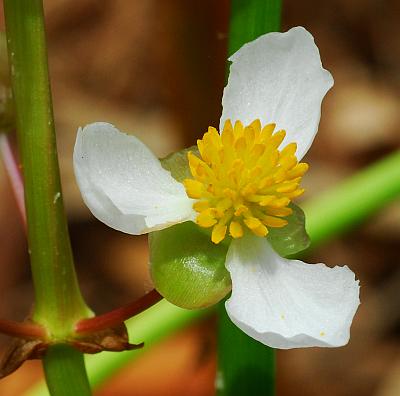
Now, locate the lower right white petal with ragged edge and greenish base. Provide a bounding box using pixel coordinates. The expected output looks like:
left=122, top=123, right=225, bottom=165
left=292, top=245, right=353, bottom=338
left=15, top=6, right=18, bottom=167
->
left=226, top=236, right=360, bottom=349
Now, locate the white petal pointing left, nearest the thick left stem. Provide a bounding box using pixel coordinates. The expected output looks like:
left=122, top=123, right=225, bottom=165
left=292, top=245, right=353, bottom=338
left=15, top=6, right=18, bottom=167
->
left=74, top=122, right=195, bottom=234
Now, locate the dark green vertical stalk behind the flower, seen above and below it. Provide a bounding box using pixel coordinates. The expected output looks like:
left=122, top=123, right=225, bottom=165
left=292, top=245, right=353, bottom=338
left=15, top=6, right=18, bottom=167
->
left=216, top=0, right=281, bottom=396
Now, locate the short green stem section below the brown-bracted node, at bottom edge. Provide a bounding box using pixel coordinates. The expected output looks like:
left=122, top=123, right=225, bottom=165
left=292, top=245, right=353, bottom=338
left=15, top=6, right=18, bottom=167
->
left=43, top=344, right=91, bottom=396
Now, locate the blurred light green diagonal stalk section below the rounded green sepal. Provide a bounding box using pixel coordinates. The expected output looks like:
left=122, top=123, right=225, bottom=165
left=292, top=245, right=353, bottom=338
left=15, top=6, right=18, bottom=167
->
left=24, top=300, right=211, bottom=396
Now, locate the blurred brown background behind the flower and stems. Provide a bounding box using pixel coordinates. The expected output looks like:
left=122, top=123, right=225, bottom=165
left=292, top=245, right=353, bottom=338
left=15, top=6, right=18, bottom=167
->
left=0, top=0, right=400, bottom=396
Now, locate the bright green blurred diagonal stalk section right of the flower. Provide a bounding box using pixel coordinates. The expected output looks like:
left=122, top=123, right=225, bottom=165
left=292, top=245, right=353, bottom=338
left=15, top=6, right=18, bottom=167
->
left=301, top=151, right=400, bottom=249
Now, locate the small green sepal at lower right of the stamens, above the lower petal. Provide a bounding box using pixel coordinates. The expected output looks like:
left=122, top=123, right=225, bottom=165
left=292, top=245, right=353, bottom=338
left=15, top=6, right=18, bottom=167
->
left=267, top=203, right=310, bottom=257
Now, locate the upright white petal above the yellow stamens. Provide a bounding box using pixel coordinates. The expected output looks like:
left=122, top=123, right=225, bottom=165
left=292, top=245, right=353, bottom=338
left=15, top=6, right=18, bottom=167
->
left=220, top=27, right=333, bottom=160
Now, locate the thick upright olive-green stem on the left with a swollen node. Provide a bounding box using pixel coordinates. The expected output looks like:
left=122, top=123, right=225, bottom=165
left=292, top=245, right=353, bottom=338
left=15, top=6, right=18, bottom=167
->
left=3, top=0, right=91, bottom=396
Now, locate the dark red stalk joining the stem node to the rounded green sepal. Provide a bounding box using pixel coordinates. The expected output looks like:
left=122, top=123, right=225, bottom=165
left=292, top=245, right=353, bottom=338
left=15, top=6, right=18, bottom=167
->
left=75, top=289, right=163, bottom=333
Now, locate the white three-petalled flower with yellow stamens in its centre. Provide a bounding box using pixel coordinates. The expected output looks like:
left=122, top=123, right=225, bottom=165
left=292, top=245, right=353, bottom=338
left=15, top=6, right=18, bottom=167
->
left=74, top=27, right=359, bottom=349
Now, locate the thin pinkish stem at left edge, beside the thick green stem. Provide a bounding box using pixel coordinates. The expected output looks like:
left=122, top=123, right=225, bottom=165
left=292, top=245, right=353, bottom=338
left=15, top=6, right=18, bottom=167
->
left=0, top=133, right=26, bottom=227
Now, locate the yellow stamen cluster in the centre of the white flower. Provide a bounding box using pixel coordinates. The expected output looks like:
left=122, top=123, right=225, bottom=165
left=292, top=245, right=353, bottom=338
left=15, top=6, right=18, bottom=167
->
left=183, top=120, right=308, bottom=243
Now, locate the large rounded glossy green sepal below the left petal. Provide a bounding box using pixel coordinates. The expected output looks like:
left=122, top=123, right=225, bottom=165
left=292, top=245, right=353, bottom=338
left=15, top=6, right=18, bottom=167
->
left=149, top=221, right=232, bottom=309
